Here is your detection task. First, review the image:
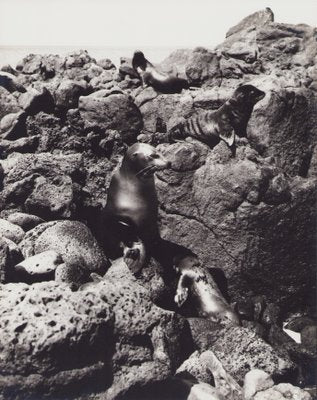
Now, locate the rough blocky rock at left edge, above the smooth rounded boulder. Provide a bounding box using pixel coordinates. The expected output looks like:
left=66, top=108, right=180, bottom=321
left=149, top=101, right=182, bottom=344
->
left=0, top=153, right=82, bottom=220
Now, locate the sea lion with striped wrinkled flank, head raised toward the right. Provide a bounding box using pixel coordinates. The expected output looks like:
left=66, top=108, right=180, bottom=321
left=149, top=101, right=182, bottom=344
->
left=169, top=85, right=265, bottom=153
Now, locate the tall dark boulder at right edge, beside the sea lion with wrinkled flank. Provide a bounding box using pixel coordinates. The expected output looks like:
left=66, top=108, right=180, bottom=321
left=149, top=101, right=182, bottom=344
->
left=248, top=87, right=317, bottom=176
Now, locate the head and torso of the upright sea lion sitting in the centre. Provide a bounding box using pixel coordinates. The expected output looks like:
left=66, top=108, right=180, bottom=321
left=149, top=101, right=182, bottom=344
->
left=104, top=143, right=171, bottom=258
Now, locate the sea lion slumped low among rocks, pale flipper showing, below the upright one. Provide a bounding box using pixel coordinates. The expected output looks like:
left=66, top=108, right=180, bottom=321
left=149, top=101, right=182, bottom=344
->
left=174, top=256, right=240, bottom=325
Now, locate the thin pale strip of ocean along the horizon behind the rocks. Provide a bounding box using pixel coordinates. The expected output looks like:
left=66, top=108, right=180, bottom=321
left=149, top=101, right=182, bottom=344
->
left=0, top=46, right=188, bottom=67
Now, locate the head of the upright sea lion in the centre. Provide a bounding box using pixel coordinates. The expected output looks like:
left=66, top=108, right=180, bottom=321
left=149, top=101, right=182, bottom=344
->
left=122, top=143, right=171, bottom=178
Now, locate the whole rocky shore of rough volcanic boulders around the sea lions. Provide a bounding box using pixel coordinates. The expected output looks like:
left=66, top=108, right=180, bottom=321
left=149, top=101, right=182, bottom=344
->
left=0, top=9, right=317, bottom=400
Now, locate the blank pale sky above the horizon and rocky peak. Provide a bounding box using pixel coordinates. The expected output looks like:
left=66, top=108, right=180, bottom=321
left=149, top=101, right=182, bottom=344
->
left=0, top=0, right=317, bottom=47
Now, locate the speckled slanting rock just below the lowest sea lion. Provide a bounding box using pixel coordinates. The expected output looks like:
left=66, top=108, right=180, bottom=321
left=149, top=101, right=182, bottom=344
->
left=212, top=327, right=296, bottom=384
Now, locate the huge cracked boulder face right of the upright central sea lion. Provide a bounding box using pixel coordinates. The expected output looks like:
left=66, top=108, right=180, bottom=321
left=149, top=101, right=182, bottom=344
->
left=156, top=141, right=316, bottom=307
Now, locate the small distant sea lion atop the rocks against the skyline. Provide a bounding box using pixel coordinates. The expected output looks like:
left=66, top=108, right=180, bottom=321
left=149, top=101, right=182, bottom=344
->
left=132, top=50, right=189, bottom=94
